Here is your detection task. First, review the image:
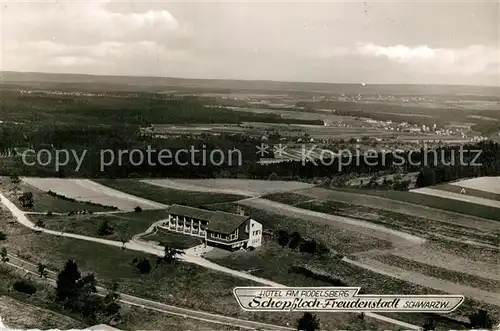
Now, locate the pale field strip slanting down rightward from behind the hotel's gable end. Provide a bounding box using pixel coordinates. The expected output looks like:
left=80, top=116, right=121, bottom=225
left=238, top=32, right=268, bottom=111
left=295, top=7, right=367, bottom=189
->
left=239, top=199, right=425, bottom=247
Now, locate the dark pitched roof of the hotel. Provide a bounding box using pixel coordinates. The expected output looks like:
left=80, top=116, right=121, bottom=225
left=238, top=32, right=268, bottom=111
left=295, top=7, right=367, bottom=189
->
left=169, top=205, right=249, bottom=234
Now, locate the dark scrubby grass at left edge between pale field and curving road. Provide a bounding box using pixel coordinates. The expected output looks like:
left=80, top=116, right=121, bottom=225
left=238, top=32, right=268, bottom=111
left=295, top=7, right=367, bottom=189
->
left=0, top=177, right=116, bottom=213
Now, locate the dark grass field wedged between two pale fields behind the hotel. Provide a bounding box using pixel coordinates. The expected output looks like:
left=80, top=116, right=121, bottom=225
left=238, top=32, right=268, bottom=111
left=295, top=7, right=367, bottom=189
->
left=96, top=179, right=244, bottom=207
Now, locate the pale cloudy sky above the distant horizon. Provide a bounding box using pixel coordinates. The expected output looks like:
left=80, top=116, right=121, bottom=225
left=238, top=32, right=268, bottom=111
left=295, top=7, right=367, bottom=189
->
left=0, top=0, right=500, bottom=85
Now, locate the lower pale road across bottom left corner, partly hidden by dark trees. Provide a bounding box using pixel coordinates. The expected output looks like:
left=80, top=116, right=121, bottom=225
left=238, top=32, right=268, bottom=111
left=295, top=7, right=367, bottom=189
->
left=2, top=254, right=295, bottom=331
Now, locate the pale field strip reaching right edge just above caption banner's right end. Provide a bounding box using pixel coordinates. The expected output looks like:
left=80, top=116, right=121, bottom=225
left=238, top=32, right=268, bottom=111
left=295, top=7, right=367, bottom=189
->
left=345, top=258, right=500, bottom=306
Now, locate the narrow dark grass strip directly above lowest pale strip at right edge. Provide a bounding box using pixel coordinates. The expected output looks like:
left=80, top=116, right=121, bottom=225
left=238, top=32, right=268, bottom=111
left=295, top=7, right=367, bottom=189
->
left=374, top=254, right=500, bottom=292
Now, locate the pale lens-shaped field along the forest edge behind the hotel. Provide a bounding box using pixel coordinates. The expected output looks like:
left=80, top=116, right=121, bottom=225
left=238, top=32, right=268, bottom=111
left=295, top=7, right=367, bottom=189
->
left=143, top=178, right=313, bottom=197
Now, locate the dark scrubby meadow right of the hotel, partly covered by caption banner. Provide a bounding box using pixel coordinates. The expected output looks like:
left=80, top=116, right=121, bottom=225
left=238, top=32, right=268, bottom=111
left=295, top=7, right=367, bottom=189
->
left=206, top=243, right=495, bottom=329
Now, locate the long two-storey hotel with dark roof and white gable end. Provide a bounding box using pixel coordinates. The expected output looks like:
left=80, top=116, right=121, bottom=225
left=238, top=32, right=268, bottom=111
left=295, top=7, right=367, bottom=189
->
left=160, top=205, right=262, bottom=250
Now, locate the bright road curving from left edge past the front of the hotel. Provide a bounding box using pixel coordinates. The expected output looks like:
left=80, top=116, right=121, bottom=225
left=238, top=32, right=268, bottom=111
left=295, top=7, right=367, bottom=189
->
left=0, top=193, right=421, bottom=331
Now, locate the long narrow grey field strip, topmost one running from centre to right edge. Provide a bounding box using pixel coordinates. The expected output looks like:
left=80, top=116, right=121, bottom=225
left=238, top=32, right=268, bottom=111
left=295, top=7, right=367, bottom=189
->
left=294, top=187, right=500, bottom=232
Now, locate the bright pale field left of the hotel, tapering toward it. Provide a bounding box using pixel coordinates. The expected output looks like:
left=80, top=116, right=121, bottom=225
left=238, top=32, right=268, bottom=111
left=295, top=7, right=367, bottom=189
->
left=22, top=177, right=167, bottom=211
